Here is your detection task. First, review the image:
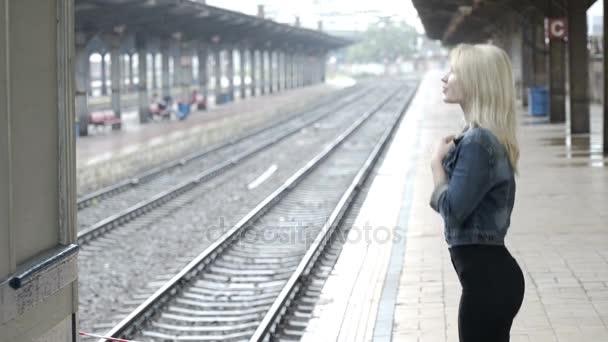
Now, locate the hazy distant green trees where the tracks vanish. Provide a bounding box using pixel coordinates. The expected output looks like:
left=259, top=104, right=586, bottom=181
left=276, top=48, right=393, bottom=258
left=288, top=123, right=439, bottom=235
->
left=346, top=17, right=420, bottom=64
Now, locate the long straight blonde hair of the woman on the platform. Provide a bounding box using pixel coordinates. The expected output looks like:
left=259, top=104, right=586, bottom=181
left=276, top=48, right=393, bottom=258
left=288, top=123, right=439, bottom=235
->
left=450, top=44, right=519, bottom=173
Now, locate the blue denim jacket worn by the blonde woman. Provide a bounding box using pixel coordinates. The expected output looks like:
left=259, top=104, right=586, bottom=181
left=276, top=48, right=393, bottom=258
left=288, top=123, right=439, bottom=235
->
left=431, top=127, right=515, bottom=247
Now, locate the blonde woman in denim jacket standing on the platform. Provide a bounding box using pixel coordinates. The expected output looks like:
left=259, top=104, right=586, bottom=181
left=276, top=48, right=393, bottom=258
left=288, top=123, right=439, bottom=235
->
left=431, top=44, right=525, bottom=342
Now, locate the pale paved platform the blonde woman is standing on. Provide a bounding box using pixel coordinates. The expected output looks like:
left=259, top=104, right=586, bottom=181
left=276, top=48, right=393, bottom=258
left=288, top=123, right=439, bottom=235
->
left=302, top=72, right=608, bottom=342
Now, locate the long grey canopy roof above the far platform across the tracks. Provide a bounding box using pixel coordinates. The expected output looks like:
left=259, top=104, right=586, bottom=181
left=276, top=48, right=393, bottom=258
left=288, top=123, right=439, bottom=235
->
left=75, top=0, right=352, bottom=51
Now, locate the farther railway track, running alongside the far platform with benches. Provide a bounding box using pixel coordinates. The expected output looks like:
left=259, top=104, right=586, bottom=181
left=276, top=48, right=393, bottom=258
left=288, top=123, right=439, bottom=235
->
left=77, top=86, right=370, bottom=244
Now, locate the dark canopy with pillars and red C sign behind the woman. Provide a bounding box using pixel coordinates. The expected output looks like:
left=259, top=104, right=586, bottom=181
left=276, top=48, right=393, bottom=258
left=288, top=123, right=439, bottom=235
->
left=413, top=0, right=608, bottom=155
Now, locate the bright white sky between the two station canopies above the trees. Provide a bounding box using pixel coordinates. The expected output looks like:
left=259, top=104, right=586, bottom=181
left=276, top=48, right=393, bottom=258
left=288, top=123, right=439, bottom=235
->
left=207, top=0, right=424, bottom=33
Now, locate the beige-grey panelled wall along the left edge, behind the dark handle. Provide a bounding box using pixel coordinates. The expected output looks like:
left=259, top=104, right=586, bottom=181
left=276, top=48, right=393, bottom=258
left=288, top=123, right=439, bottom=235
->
left=0, top=0, right=77, bottom=341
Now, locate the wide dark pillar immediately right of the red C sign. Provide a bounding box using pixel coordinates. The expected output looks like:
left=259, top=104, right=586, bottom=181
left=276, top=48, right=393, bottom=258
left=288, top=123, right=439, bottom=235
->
left=568, top=0, right=590, bottom=134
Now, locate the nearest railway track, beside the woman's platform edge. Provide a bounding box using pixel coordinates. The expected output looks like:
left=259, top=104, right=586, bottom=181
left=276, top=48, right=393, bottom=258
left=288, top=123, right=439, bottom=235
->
left=97, top=81, right=414, bottom=341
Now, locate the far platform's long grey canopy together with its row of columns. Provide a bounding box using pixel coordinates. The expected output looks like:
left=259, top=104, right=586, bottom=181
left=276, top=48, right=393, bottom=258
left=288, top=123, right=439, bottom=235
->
left=75, top=0, right=351, bottom=136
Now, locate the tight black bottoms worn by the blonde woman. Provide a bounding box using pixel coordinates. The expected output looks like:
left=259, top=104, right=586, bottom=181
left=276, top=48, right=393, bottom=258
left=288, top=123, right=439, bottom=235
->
left=449, top=244, right=525, bottom=342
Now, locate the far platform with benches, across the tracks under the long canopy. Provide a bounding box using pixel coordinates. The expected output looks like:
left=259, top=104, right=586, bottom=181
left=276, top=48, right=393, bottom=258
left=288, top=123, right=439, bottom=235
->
left=76, top=83, right=345, bottom=193
